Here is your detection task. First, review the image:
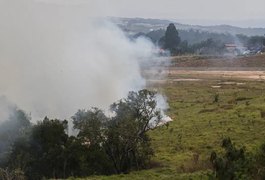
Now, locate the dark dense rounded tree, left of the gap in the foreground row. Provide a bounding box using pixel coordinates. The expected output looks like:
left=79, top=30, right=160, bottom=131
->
left=30, top=117, right=68, bottom=178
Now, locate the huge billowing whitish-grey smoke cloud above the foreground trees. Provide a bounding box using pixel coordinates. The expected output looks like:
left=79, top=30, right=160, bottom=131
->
left=0, top=0, right=168, bottom=121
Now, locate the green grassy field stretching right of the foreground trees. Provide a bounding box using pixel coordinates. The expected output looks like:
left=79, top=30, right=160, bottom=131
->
left=75, top=80, right=265, bottom=180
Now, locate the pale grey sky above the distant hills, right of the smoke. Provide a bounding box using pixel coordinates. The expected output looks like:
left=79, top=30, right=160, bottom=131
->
left=106, top=0, right=265, bottom=26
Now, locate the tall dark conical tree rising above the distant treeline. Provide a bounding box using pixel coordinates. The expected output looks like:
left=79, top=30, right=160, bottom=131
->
left=160, top=23, right=180, bottom=55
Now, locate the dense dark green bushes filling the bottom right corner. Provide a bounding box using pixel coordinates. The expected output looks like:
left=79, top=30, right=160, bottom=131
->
left=209, top=138, right=265, bottom=180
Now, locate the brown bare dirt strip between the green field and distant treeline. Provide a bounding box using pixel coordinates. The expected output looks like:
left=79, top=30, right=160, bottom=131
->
left=144, top=55, right=265, bottom=83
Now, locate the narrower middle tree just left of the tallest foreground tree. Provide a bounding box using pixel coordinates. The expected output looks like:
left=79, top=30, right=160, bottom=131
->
left=72, top=108, right=114, bottom=175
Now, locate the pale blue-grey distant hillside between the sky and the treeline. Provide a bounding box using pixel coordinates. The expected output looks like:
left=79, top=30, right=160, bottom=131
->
left=110, top=18, right=265, bottom=36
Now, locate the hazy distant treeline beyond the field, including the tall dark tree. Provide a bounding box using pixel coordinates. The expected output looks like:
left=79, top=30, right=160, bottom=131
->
left=133, top=23, right=265, bottom=55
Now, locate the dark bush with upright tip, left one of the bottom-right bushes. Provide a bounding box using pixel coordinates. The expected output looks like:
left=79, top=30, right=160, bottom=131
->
left=210, top=138, right=250, bottom=180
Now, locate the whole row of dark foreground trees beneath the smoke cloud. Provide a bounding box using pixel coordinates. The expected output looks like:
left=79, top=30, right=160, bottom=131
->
left=0, top=90, right=161, bottom=180
